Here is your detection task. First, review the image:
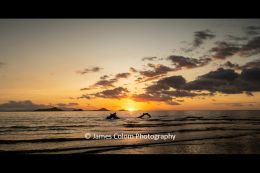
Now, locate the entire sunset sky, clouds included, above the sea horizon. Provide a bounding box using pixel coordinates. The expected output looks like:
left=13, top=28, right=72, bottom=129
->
left=0, top=19, right=260, bottom=110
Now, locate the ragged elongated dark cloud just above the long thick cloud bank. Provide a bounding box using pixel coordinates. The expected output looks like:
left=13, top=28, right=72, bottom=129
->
left=166, top=55, right=211, bottom=70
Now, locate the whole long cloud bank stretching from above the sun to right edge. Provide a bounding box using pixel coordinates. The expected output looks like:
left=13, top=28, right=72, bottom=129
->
left=132, top=68, right=260, bottom=104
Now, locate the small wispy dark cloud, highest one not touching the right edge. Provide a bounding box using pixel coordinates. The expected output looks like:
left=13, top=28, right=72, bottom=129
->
left=193, top=30, right=215, bottom=48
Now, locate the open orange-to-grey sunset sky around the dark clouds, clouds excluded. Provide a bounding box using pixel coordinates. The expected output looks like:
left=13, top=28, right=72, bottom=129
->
left=0, top=19, right=260, bottom=110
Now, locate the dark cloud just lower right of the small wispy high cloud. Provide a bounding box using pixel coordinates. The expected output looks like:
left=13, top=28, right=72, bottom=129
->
left=210, top=41, right=241, bottom=59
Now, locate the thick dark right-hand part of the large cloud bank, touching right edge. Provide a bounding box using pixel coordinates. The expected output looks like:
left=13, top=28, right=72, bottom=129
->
left=183, top=68, right=260, bottom=94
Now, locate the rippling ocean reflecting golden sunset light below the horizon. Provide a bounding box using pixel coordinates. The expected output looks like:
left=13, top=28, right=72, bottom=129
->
left=0, top=110, right=260, bottom=154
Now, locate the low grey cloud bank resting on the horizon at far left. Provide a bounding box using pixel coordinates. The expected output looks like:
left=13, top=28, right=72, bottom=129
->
left=0, top=100, right=50, bottom=111
